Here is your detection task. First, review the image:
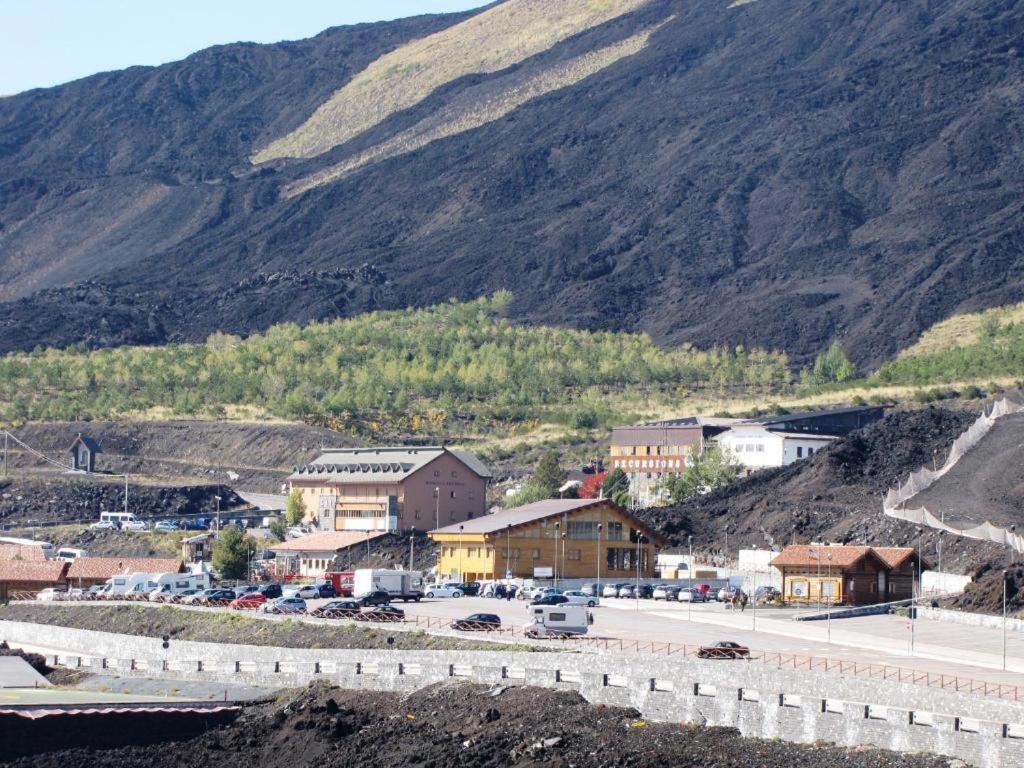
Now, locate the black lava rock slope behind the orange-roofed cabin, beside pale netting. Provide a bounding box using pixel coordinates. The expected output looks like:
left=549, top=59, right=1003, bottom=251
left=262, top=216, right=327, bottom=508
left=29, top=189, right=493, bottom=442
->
left=641, top=408, right=1009, bottom=571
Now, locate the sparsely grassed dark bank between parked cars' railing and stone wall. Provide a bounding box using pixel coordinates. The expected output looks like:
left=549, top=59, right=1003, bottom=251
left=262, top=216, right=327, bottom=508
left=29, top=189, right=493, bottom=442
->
left=0, top=604, right=535, bottom=650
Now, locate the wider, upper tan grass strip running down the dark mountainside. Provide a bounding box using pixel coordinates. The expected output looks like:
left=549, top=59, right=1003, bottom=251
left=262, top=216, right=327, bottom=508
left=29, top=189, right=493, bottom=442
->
left=252, top=0, right=648, bottom=163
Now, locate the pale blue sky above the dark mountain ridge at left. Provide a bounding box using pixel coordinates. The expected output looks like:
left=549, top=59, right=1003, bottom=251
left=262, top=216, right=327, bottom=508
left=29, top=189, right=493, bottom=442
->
left=0, top=0, right=485, bottom=94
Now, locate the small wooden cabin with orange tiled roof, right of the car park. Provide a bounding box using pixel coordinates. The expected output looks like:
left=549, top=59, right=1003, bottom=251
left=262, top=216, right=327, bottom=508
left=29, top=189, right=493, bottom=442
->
left=771, top=544, right=929, bottom=605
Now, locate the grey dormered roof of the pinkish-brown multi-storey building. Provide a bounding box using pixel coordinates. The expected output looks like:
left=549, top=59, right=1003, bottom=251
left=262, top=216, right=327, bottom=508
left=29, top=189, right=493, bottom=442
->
left=288, top=445, right=490, bottom=482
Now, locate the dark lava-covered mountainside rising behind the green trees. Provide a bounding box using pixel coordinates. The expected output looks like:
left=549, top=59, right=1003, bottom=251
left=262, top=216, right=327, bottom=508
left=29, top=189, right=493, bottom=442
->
left=0, top=0, right=1024, bottom=365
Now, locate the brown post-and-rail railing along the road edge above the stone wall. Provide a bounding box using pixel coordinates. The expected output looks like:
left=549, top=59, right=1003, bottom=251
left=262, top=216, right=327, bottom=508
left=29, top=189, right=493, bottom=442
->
left=10, top=592, right=1024, bottom=701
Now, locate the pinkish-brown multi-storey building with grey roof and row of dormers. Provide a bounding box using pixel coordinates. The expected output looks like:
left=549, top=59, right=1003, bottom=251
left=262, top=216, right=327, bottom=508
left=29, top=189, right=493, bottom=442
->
left=288, top=447, right=490, bottom=530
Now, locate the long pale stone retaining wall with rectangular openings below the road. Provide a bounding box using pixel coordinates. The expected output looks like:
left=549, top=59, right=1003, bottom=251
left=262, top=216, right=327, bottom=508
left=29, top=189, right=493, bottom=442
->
left=0, top=622, right=1024, bottom=768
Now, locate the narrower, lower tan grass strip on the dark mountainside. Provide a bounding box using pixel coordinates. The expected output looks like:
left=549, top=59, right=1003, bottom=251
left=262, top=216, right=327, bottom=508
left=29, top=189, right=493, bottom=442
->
left=285, top=23, right=664, bottom=197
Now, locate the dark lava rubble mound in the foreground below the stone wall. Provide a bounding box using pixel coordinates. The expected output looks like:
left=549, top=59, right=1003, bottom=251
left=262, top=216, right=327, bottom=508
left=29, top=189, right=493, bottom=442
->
left=0, top=684, right=949, bottom=768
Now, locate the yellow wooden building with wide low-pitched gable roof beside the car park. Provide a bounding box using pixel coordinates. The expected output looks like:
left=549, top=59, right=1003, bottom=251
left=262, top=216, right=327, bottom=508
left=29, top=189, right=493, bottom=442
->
left=430, top=499, right=663, bottom=581
